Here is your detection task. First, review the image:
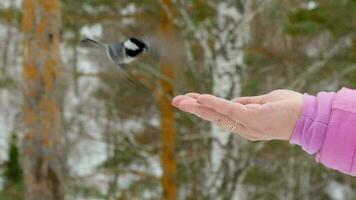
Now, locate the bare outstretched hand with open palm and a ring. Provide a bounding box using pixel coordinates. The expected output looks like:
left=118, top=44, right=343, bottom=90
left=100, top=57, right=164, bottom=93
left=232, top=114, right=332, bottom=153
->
left=172, top=90, right=303, bottom=140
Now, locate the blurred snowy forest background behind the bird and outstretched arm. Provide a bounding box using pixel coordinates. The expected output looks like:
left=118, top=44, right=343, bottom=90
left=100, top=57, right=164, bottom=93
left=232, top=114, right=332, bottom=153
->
left=0, top=0, right=356, bottom=200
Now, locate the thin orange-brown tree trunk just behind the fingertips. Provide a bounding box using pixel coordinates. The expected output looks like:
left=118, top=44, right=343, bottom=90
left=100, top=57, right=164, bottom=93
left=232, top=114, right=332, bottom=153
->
left=159, top=0, right=177, bottom=200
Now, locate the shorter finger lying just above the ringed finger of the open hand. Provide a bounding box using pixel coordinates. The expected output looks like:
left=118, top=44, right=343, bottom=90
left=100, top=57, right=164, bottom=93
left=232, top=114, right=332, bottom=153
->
left=197, top=94, right=248, bottom=124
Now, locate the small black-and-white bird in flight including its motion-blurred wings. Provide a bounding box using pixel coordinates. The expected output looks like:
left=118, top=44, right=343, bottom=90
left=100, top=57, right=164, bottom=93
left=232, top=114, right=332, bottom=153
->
left=80, top=35, right=184, bottom=85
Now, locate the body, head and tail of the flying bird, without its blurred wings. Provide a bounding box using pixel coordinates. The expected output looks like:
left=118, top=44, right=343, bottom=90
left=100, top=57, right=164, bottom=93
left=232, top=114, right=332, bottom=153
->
left=80, top=37, right=150, bottom=66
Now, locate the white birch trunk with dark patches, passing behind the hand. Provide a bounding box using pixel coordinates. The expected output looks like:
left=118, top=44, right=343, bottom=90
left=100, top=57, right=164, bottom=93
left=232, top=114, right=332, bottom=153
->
left=209, top=0, right=252, bottom=199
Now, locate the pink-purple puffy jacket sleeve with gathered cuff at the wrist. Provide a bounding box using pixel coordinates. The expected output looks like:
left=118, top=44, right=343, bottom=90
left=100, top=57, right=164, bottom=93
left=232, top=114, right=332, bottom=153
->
left=290, top=88, right=356, bottom=176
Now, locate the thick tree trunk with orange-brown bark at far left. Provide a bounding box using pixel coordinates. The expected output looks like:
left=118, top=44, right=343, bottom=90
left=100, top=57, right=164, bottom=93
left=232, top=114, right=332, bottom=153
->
left=22, top=0, right=64, bottom=200
